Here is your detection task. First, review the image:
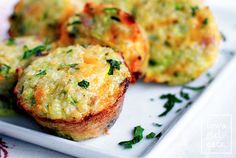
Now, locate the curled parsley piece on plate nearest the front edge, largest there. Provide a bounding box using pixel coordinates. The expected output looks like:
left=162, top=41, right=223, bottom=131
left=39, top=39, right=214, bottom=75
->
left=119, top=126, right=144, bottom=149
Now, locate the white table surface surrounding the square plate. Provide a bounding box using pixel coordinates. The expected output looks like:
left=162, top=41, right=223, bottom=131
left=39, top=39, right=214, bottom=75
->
left=0, top=0, right=236, bottom=158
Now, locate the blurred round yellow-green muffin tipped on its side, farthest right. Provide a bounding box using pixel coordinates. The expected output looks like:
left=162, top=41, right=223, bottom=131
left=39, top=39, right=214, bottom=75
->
left=133, top=0, right=220, bottom=85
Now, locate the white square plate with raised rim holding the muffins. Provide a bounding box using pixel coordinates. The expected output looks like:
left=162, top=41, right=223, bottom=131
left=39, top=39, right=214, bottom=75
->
left=0, top=3, right=236, bottom=158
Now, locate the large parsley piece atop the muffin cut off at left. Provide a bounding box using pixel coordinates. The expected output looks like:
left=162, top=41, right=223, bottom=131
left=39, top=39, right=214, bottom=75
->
left=23, top=45, right=47, bottom=59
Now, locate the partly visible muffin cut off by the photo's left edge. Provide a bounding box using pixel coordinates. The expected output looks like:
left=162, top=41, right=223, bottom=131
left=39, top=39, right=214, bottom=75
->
left=0, top=37, right=47, bottom=96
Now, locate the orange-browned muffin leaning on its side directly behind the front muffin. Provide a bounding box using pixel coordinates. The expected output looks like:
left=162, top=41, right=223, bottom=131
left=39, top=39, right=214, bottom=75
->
left=60, top=3, right=149, bottom=81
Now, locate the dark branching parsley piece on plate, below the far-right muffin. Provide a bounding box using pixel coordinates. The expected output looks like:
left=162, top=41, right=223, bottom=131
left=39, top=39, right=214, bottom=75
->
left=158, top=94, right=182, bottom=117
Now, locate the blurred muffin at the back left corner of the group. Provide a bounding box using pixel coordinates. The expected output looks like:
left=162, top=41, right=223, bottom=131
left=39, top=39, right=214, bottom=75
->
left=10, top=0, right=74, bottom=41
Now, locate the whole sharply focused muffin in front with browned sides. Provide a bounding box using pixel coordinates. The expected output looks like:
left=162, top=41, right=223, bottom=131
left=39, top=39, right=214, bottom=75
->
left=15, top=45, right=130, bottom=141
